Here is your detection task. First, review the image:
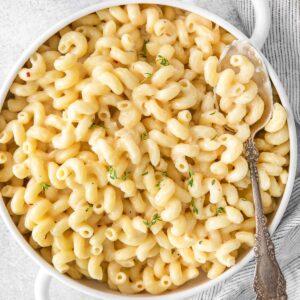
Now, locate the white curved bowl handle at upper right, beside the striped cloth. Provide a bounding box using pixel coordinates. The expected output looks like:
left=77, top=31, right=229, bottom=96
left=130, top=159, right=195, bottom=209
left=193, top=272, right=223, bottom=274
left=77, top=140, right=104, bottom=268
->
left=184, top=0, right=271, bottom=49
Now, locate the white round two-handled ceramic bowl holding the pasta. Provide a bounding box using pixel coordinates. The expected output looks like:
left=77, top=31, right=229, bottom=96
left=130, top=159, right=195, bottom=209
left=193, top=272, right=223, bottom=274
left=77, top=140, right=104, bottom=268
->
left=0, top=0, right=297, bottom=300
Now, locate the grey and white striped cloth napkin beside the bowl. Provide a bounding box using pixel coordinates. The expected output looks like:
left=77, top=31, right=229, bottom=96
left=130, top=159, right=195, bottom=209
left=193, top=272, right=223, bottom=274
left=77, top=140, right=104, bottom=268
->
left=190, top=0, right=300, bottom=300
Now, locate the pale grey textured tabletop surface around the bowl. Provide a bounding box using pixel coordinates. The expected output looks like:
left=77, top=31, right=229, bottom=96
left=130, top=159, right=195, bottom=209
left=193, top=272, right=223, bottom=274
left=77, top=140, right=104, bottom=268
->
left=0, top=0, right=298, bottom=300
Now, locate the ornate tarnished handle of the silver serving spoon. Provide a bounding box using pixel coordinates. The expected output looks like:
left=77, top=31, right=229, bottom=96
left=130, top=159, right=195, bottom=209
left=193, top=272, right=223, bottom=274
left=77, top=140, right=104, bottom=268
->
left=245, top=137, right=287, bottom=300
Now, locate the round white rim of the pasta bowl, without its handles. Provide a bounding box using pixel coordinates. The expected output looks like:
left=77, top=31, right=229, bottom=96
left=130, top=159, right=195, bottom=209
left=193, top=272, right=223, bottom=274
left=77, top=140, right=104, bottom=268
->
left=0, top=0, right=297, bottom=300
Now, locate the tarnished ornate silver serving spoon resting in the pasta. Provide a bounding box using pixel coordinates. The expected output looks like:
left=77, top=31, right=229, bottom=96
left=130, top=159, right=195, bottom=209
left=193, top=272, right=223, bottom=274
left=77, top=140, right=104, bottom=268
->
left=218, top=41, right=287, bottom=300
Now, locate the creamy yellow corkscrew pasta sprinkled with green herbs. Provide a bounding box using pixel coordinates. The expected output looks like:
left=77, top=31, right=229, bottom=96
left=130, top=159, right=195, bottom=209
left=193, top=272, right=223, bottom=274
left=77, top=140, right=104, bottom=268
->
left=0, top=4, right=289, bottom=294
